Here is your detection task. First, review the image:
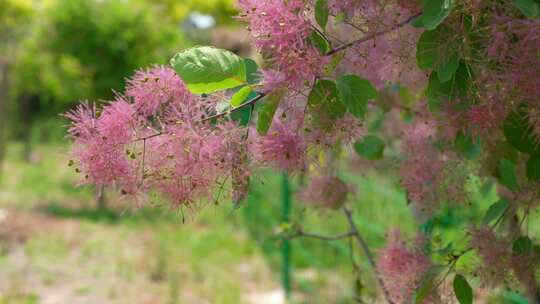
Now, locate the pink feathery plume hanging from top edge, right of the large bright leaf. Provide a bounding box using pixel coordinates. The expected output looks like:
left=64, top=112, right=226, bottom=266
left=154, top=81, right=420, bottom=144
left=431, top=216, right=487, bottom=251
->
left=238, top=0, right=328, bottom=88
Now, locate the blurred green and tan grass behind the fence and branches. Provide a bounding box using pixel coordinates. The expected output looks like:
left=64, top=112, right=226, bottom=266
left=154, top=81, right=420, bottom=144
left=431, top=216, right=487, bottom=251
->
left=0, top=143, right=538, bottom=304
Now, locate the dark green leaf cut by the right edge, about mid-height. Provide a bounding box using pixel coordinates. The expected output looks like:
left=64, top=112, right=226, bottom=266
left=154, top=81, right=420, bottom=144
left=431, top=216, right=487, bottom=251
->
left=503, top=103, right=540, bottom=154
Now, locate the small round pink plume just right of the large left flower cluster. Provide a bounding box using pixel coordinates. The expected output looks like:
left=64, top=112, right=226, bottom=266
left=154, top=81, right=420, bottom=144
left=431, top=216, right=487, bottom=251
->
left=250, top=119, right=306, bottom=172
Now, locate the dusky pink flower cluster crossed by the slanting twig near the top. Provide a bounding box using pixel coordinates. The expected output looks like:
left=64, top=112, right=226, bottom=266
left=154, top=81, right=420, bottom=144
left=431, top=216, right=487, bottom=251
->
left=336, top=1, right=427, bottom=89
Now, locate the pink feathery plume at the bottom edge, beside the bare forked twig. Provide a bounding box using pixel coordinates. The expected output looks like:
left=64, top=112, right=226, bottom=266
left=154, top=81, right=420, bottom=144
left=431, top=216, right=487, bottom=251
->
left=377, top=231, right=434, bottom=303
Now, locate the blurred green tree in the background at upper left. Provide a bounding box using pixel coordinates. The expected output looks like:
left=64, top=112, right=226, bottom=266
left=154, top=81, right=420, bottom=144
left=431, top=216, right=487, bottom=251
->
left=11, top=0, right=185, bottom=148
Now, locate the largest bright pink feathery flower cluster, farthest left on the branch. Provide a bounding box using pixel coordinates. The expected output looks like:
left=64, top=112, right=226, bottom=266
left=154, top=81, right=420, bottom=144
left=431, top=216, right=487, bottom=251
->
left=66, top=67, right=242, bottom=205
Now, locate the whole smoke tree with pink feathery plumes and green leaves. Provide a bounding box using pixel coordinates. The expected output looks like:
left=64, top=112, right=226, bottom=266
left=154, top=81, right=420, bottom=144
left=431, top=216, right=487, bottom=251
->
left=66, top=0, right=540, bottom=303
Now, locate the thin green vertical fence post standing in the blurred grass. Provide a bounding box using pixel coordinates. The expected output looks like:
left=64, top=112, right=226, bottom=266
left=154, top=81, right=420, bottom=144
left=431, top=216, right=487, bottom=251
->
left=281, top=172, right=291, bottom=298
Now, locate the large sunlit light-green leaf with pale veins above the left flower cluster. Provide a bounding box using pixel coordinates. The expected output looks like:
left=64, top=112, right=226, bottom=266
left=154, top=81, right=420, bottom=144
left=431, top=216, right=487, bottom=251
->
left=171, top=46, right=246, bottom=94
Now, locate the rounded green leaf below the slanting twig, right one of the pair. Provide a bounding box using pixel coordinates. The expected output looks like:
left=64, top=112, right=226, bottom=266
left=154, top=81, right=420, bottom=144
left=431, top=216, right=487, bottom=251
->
left=337, top=75, right=378, bottom=119
